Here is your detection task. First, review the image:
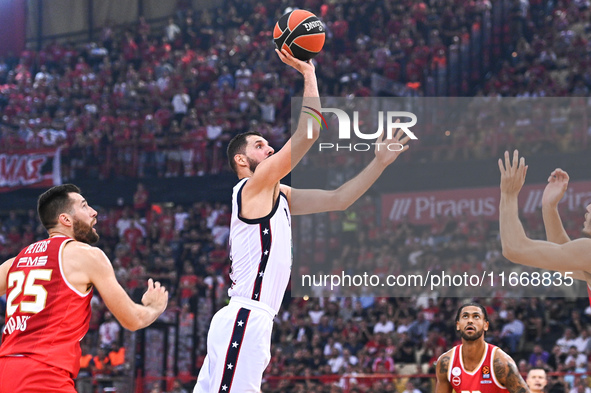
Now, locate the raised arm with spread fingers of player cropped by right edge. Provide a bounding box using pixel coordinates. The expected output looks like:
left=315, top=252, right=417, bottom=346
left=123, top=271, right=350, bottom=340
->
left=499, top=150, right=591, bottom=272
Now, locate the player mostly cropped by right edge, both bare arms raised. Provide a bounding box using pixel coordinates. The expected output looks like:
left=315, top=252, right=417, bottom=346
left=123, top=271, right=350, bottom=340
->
left=499, top=150, right=591, bottom=298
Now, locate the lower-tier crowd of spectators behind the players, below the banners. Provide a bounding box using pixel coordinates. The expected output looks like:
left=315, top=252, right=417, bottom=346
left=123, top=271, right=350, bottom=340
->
left=0, top=180, right=591, bottom=393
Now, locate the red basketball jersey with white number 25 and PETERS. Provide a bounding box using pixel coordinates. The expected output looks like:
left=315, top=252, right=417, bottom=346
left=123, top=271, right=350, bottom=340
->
left=0, top=236, right=92, bottom=377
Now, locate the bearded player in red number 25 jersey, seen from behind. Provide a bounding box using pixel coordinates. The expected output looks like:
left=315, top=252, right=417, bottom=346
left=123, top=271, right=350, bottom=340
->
left=0, top=184, right=168, bottom=393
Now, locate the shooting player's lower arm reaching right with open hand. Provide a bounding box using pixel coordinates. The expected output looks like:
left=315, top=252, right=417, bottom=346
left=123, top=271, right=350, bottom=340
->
left=281, top=125, right=409, bottom=215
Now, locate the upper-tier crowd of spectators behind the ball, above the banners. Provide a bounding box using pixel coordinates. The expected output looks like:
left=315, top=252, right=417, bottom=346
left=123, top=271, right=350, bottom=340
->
left=0, top=0, right=591, bottom=178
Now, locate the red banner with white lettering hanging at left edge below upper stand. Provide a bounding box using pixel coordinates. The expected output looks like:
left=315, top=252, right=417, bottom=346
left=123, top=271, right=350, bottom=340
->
left=0, top=149, right=61, bottom=192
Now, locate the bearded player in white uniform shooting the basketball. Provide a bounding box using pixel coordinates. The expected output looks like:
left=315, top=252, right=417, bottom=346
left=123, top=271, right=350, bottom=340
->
left=194, top=52, right=408, bottom=393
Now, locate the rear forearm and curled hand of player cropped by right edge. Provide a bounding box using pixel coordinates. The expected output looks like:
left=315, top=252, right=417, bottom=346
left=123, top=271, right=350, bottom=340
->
left=542, top=168, right=570, bottom=244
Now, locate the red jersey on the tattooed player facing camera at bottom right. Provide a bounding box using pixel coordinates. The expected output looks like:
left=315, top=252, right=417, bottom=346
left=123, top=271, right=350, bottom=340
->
left=447, top=343, right=507, bottom=393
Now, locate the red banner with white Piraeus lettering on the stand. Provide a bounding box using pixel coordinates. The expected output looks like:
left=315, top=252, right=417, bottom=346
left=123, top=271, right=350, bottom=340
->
left=382, top=181, right=591, bottom=224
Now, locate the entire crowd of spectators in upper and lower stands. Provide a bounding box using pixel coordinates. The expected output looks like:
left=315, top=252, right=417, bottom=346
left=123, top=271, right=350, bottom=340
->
left=0, top=0, right=591, bottom=393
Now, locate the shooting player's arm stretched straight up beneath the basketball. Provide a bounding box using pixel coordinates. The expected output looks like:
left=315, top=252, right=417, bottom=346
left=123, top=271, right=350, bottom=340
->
left=248, top=50, right=320, bottom=193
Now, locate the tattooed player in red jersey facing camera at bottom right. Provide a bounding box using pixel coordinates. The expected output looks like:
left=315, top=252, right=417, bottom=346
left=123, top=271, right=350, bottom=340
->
left=435, top=303, right=529, bottom=393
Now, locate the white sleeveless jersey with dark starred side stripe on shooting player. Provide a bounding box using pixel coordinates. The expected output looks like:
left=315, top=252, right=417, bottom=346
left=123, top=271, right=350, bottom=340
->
left=228, top=178, right=292, bottom=313
